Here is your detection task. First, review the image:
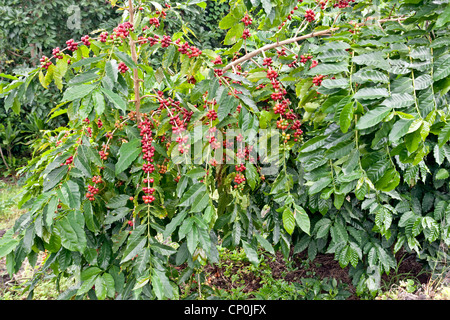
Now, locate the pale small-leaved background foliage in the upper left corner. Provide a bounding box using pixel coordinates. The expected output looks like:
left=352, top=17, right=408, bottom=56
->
left=0, top=0, right=120, bottom=73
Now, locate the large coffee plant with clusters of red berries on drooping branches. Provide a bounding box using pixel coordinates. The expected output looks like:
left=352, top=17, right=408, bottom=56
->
left=0, top=0, right=450, bottom=299
